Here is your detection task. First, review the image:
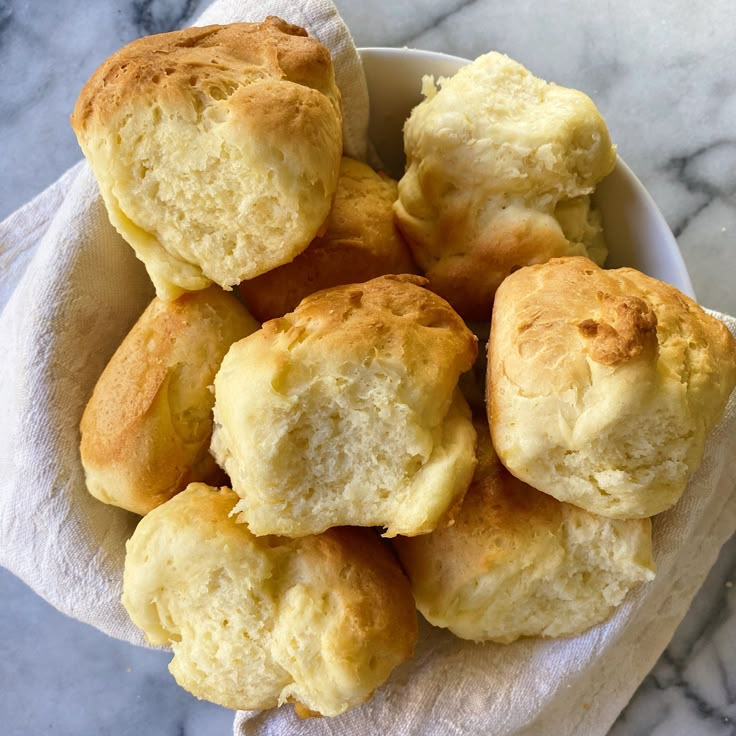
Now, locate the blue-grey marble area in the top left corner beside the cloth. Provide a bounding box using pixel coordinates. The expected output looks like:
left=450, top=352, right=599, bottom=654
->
left=0, top=0, right=208, bottom=218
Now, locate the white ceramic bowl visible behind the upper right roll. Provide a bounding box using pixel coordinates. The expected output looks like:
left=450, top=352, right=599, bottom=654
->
left=360, top=48, right=695, bottom=298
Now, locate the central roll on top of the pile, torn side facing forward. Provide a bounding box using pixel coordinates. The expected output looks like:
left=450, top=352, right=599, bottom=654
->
left=212, top=275, right=477, bottom=537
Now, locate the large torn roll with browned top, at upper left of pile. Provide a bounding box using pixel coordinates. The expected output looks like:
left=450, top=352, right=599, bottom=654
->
left=72, top=18, right=342, bottom=299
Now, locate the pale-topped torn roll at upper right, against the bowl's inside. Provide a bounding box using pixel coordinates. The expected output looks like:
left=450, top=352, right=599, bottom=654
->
left=395, top=53, right=616, bottom=320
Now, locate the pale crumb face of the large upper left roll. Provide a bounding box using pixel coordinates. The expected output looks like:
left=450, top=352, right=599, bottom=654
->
left=111, top=90, right=314, bottom=285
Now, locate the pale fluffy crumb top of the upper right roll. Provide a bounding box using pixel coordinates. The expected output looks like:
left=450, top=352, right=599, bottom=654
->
left=405, top=53, right=615, bottom=211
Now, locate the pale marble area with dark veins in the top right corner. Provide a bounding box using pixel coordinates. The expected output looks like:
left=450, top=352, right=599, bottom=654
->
left=344, top=0, right=736, bottom=314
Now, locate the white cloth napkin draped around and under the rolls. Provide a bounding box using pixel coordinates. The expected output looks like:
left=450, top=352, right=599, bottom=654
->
left=0, top=0, right=736, bottom=736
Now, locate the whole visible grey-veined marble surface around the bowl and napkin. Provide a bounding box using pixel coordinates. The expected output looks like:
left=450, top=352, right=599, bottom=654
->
left=0, top=0, right=736, bottom=736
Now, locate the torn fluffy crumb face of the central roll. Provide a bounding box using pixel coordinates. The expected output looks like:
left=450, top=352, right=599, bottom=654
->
left=236, top=360, right=474, bottom=534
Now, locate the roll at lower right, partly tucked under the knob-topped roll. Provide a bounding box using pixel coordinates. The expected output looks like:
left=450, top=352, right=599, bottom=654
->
left=393, top=419, right=654, bottom=644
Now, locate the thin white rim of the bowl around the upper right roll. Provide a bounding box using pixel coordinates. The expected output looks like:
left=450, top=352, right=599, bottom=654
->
left=357, top=46, right=697, bottom=301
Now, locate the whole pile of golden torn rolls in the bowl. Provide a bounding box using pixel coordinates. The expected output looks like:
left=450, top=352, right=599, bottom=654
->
left=72, top=18, right=736, bottom=716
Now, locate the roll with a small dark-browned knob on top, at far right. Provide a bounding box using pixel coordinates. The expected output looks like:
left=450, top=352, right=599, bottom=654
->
left=487, top=258, right=736, bottom=519
